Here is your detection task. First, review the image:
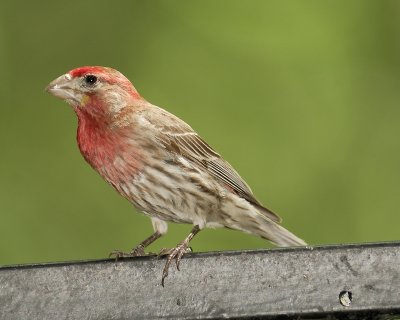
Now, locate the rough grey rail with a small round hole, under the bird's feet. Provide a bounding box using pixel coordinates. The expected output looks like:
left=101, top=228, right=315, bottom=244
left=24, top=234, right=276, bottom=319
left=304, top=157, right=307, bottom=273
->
left=0, top=243, right=400, bottom=320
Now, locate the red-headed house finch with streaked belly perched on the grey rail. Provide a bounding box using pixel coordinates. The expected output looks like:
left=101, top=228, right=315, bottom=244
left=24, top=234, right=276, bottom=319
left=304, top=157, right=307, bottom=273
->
left=47, top=66, right=306, bottom=285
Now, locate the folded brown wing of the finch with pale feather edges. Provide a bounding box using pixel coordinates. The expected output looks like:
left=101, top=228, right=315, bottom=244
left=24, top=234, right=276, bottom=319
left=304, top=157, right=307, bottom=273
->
left=142, top=107, right=281, bottom=223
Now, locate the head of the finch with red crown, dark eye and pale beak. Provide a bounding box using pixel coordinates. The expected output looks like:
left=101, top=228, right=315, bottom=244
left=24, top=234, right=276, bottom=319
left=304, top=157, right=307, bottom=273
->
left=46, top=66, right=141, bottom=116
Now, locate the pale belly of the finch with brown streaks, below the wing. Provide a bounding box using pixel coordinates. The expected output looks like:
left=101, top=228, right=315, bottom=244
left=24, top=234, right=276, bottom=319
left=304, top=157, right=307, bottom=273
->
left=115, top=162, right=224, bottom=227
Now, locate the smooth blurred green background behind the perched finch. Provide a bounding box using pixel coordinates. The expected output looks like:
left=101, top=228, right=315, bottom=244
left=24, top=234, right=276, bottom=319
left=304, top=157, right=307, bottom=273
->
left=0, top=0, right=400, bottom=264
